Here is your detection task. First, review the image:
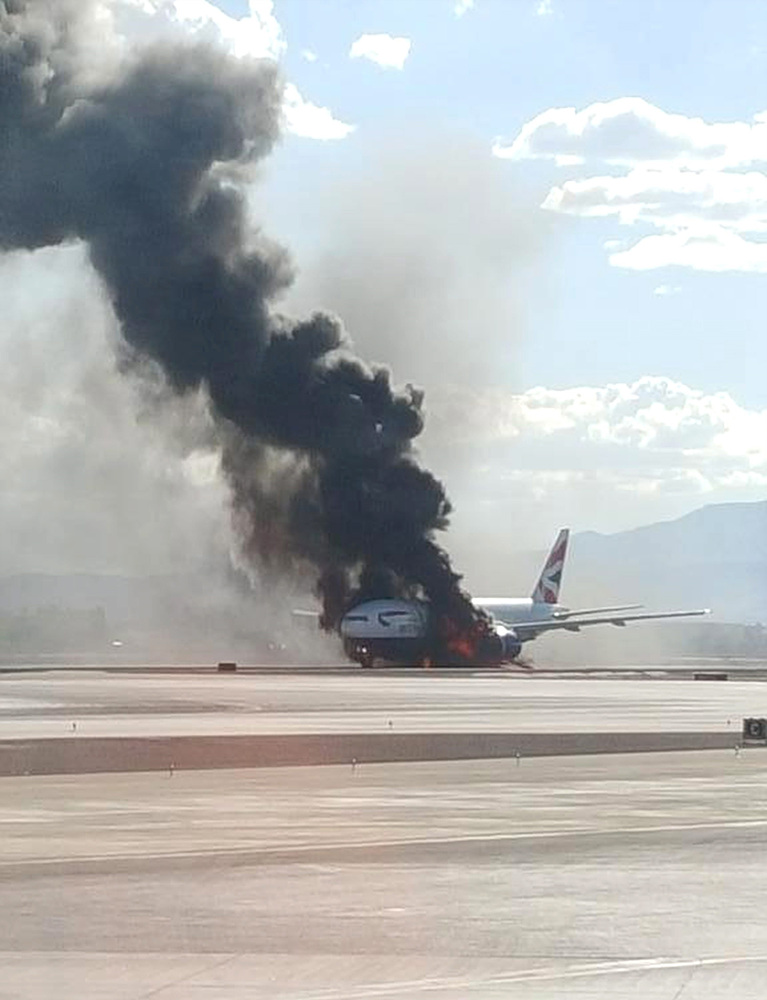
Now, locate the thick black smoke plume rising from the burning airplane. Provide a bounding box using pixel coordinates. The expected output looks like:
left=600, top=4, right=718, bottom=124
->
left=0, top=0, right=486, bottom=652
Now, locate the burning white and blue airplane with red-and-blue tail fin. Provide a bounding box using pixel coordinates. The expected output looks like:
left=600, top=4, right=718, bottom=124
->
left=339, top=528, right=710, bottom=667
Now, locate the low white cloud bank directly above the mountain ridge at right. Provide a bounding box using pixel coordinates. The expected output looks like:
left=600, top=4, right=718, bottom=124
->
left=431, top=375, right=767, bottom=493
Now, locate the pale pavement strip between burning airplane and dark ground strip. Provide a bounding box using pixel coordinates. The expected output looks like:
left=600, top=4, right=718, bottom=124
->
left=0, top=671, right=767, bottom=739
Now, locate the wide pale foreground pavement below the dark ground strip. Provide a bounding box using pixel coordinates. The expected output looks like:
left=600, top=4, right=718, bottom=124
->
left=0, top=751, right=767, bottom=1000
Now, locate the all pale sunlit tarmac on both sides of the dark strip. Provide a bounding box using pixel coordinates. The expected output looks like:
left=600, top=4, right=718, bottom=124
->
left=0, top=673, right=767, bottom=1000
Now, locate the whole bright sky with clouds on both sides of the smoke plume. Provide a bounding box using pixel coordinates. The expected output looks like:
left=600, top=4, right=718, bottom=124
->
left=0, top=0, right=767, bottom=585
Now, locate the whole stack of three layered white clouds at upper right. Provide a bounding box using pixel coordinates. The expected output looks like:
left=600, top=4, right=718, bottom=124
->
left=494, top=97, right=767, bottom=272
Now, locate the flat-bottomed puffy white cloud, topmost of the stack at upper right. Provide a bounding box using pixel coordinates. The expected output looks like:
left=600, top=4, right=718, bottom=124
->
left=493, top=97, right=767, bottom=168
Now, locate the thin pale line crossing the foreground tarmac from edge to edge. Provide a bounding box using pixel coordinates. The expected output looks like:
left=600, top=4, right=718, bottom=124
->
left=0, top=819, right=767, bottom=873
